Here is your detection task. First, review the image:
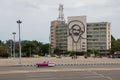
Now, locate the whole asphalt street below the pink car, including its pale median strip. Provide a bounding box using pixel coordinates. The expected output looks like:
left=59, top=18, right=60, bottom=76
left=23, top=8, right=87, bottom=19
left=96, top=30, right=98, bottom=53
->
left=0, top=64, right=120, bottom=80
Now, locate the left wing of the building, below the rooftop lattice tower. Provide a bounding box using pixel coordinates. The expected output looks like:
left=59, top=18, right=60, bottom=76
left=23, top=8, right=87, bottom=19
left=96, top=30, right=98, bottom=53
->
left=51, top=20, right=67, bottom=53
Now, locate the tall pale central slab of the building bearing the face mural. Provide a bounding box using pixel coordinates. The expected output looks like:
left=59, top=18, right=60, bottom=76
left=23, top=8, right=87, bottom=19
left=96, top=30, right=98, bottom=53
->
left=67, top=16, right=87, bottom=52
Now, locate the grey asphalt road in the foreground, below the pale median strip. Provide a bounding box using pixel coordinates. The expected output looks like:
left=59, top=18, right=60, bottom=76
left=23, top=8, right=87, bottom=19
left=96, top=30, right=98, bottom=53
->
left=0, top=70, right=120, bottom=80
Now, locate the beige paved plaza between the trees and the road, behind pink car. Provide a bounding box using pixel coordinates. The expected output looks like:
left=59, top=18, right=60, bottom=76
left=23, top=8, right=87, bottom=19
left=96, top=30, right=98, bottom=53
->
left=0, top=56, right=120, bottom=66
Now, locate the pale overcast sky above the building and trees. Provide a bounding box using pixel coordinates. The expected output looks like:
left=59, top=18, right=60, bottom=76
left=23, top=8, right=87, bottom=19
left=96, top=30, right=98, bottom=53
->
left=0, top=0, right=120, bottom=43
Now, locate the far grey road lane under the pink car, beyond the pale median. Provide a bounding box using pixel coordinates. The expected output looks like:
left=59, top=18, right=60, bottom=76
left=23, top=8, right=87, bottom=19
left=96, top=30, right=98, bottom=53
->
left=0, top=64, right=120, bottom=71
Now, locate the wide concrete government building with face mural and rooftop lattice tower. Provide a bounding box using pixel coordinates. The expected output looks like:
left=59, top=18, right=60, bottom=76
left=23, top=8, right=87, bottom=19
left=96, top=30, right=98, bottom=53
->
left=50, top=4, right=111, bottom=53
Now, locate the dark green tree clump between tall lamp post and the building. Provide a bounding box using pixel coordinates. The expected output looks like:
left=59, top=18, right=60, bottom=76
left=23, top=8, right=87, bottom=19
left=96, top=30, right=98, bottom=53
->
left=22, top=40, right=45, bottom=57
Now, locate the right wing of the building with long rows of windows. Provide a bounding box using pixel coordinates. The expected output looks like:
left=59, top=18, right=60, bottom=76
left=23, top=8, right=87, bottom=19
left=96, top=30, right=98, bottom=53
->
left=87, top=22, right=111, bottom=53
